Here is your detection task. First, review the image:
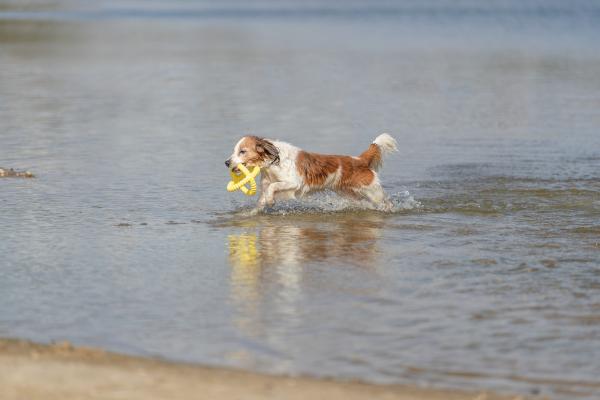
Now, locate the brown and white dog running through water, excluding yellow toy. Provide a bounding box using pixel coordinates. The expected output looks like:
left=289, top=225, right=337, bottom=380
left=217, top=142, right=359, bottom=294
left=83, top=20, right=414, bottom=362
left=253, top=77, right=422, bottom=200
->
left=225, top=133, right=397, bottom=211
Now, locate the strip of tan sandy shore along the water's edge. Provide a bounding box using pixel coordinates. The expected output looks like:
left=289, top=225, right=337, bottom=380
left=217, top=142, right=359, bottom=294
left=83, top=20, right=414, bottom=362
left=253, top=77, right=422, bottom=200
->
left=0, top=339, right=524, bottom=400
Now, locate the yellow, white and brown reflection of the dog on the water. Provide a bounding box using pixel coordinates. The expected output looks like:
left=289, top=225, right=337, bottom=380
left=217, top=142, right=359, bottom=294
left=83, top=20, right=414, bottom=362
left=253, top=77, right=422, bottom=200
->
left=228, top=212, right=385, bottom=342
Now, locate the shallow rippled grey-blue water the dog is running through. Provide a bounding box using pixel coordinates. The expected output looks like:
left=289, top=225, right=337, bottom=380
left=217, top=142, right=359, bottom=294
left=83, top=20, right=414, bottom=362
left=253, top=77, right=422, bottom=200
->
left=0, top=1, right=600, bottom=399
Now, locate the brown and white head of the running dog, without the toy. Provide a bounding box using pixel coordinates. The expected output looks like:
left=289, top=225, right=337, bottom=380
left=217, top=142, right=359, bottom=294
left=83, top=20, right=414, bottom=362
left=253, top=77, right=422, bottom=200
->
left=225, top=136, right=279, bottom=171
